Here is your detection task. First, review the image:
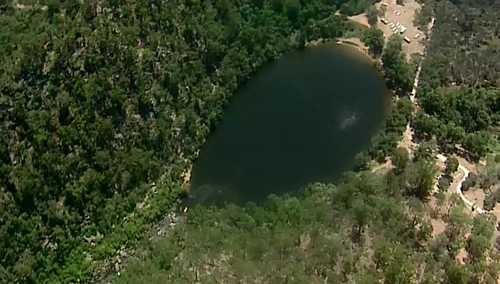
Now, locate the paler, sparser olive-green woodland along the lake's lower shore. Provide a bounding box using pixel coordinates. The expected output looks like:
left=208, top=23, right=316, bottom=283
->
left=114, top=166, right=500, bottom=284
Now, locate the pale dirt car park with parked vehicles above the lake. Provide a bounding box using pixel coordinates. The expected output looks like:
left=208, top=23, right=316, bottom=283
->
left=375, top=0, right=425, bottom=59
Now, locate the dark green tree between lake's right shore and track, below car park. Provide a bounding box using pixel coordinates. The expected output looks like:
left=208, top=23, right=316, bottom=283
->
left=382, top=34, right=413, bottom=94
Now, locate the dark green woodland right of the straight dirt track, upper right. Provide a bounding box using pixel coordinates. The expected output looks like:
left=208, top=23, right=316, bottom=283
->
left=413, top=0, right=500, bottom=160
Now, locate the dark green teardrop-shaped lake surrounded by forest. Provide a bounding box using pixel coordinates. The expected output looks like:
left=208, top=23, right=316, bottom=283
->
left=186, top=45, right=389, bottom=206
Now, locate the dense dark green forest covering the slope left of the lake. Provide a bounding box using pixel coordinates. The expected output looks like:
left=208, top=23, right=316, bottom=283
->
left=0, top=0, right=356, bottom=283
